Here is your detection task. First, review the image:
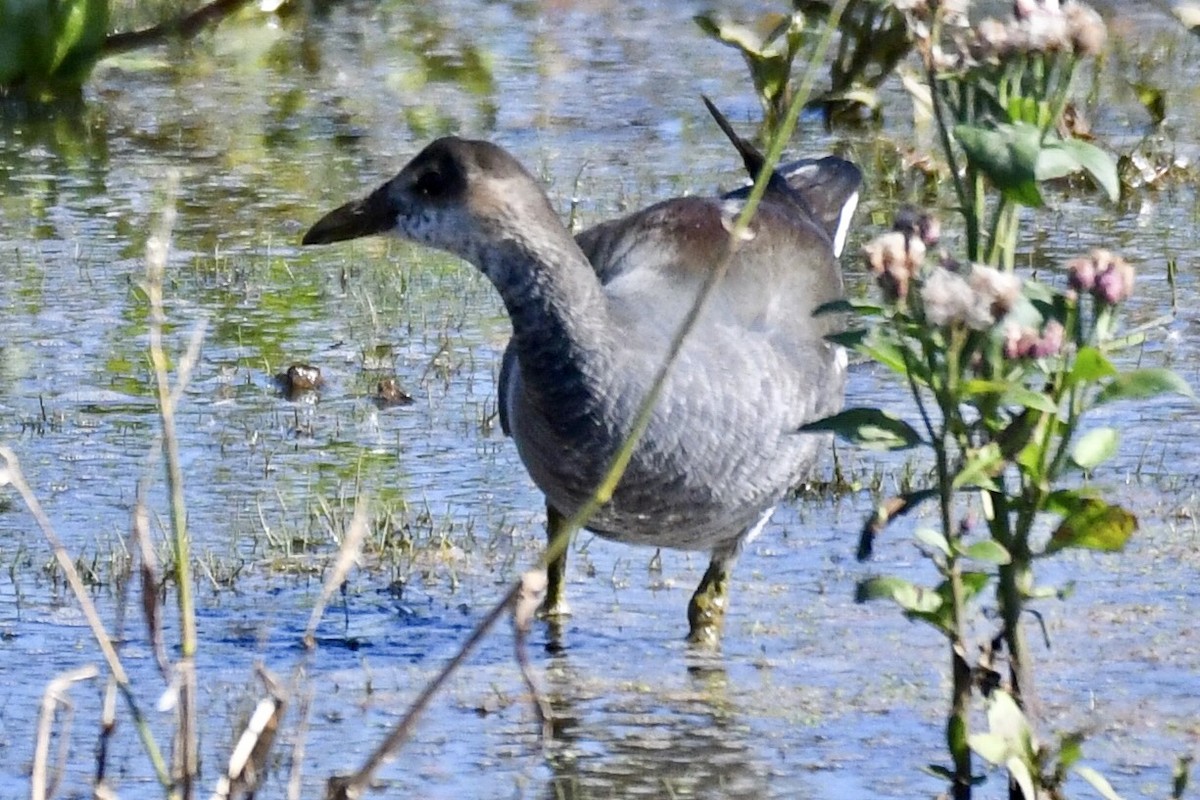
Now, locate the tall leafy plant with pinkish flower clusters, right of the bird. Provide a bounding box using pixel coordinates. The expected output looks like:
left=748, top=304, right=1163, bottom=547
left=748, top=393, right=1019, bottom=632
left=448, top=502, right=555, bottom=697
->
left=806, top=0, right=1190, bottom=800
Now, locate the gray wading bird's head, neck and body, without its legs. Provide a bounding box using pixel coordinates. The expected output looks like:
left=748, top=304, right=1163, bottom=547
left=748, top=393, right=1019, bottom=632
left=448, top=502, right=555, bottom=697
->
left=304, top=107, right=859, bottom=634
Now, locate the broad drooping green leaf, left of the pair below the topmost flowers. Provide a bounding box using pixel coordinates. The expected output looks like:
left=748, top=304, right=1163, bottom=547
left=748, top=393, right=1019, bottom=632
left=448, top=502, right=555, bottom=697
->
left=954, top=122, right=1045, bottom=207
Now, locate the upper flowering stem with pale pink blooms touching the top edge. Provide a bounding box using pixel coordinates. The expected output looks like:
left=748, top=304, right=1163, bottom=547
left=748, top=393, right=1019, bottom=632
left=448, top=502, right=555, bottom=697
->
left=895, top=0, right=1120, bottom=269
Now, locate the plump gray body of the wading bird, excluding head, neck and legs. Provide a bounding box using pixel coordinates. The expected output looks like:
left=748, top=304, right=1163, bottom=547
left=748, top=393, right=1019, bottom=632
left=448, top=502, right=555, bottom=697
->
left=502, top=160, right=857, bottom=549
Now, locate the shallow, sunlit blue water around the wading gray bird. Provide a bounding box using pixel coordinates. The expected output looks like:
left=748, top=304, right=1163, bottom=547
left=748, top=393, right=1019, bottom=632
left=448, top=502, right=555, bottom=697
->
left=0, top=2, right=1200, bottom=798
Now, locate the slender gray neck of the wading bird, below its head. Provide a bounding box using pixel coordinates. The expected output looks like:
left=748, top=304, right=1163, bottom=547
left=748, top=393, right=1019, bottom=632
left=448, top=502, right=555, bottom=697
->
left=481, top=230, right=613, bottom=414
